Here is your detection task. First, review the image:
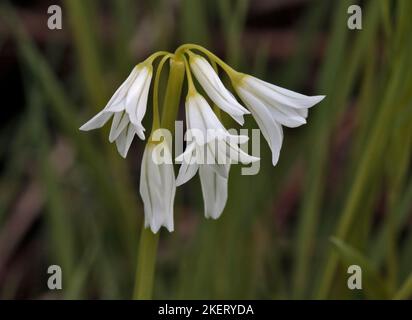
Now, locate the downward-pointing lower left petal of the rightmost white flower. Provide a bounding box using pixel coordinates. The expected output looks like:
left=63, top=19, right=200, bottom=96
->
left=237, top=87, right=283, bottom=165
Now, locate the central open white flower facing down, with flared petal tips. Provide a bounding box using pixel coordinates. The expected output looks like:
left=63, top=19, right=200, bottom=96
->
left=176, top=93, right=259, bottom=219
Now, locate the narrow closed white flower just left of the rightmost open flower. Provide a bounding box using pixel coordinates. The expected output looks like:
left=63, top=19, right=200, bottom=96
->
left=190, top=53, right=250, bottom=125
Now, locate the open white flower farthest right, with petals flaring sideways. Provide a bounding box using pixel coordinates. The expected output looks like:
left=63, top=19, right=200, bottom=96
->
left=233, top=75, right=325, bottom=165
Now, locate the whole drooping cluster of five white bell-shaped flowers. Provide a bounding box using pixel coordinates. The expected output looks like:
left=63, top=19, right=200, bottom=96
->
left=80, top=44, right=324, bottom=233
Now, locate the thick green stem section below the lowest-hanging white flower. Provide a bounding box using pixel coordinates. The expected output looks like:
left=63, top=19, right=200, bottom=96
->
left=133, top=225, right=159, bottom=300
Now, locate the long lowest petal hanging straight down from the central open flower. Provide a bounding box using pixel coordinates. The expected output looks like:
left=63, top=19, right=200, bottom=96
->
left=199, top=165, right=229, bottom=219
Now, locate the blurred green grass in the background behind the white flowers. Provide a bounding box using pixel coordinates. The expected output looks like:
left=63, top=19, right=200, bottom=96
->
left=0, top=0, right=412, bottom=299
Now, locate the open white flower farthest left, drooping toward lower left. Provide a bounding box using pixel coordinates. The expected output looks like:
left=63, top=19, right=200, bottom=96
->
left=80, top=63, right=153, bottom=157
